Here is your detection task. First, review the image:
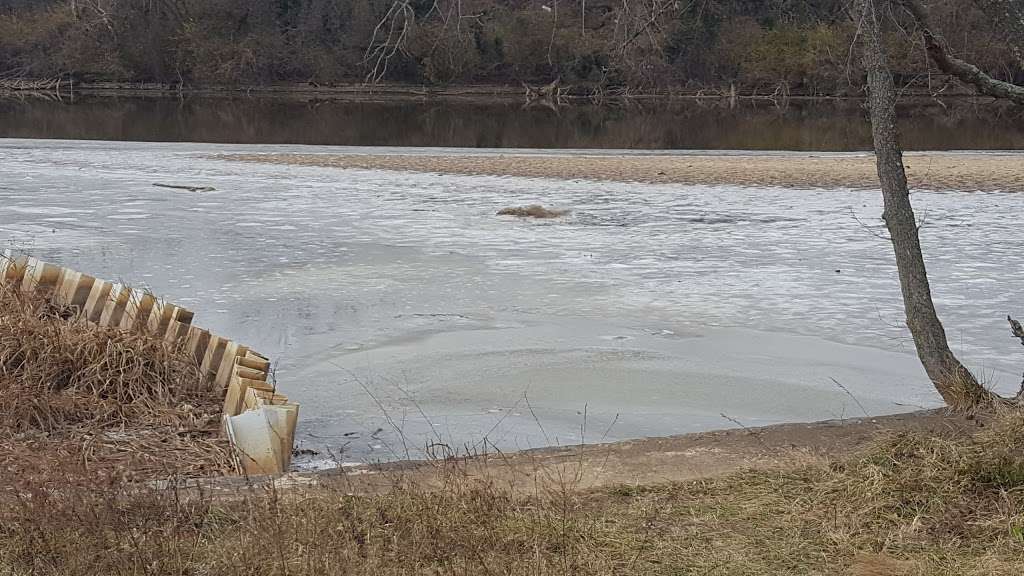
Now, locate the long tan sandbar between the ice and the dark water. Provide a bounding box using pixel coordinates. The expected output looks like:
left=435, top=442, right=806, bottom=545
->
left=226, top=153, right=1024, bottom=192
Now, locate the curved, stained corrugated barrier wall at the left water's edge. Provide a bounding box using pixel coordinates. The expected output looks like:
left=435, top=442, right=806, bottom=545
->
left=0, top=251, right=299, bottom=475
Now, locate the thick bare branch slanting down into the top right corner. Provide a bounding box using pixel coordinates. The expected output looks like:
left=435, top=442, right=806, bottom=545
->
left=902, top=0, right=1024, bottom=106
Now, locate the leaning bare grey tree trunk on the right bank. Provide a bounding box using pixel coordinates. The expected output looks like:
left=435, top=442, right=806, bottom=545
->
left=857, top=0, right=990, bottom=409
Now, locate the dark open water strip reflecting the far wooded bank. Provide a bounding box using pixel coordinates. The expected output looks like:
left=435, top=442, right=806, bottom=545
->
left=0, top=97, right=1024, bottom=151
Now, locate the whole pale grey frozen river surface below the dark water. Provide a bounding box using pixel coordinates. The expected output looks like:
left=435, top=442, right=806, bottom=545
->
left=0, top=139, right=1024, bottom=461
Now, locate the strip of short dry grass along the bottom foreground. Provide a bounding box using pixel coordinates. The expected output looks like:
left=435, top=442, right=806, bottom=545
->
left=0, top=411, right=1024, bottom=576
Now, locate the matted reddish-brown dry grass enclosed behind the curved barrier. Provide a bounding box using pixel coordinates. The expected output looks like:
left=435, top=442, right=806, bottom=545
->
left=0, top=286, right=230, bottom=483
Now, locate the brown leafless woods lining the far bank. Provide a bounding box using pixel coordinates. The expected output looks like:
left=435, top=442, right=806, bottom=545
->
left=0, top=0, right=1024, bottom=94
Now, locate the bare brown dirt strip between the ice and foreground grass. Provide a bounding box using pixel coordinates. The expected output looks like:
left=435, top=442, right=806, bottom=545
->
left=232, top=410, right=978, bottom=494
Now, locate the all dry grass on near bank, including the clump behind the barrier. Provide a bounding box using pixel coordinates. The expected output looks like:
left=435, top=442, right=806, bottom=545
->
left=0, top=278, right=1024, bottom=576
